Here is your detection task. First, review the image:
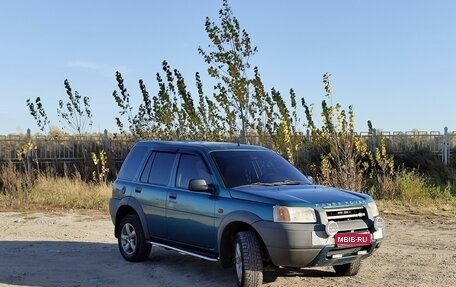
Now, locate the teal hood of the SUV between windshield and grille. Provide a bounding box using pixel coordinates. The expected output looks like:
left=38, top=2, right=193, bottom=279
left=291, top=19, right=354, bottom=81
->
left=230, top=185, right=372, bottom=207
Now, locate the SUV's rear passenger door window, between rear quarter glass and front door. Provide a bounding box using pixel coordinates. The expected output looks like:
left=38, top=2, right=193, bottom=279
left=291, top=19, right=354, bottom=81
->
left=147, top=152, right=176, bottom=185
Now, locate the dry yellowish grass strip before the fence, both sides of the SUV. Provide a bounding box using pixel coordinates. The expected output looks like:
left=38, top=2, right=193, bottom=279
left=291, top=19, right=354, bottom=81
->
left=0, top=169, right=456, bottom=214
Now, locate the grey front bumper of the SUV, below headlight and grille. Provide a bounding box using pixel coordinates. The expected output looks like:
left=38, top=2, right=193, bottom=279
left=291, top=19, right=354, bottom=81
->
left=253, top=221, right=383, bottom=267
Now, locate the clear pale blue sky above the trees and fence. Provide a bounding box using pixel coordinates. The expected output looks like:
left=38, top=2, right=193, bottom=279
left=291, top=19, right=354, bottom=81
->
left=0, top=0, right=456, bottom=135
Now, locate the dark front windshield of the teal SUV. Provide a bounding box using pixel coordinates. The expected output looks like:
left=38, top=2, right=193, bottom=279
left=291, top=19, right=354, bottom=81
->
left=211, top=151, right=310, bottom=188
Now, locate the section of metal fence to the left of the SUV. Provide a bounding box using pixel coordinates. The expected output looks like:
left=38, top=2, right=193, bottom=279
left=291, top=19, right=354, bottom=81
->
left=0, top=132, right=135, bottom=178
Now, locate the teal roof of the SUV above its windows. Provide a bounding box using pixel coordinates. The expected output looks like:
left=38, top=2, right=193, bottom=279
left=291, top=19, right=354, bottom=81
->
left=132, top=140, right=267, bottom=152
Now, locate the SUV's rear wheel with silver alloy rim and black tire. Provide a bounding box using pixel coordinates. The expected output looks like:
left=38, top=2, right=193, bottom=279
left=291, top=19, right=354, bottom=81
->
left=117, top=214, right=152, bottom=262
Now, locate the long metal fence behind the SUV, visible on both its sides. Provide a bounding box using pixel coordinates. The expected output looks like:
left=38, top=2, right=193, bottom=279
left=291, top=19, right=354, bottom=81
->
left=0, top=128, right=456, bottom=172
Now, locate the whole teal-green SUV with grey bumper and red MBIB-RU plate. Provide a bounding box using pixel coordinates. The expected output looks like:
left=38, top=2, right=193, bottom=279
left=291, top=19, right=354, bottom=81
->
left=109, top=141, right=384, bottom=286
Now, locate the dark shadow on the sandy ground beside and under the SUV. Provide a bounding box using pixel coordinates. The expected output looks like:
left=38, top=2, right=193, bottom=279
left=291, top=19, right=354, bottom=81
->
left=0, top=241, right=334, bottom=287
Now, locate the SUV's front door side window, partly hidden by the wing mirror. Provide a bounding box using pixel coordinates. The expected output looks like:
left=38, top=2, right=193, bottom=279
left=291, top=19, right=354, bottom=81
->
left=176, top=154, right=211, bottom=189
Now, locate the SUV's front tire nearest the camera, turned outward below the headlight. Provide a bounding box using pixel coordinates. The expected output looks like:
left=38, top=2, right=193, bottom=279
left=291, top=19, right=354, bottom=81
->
left=234, top=231, right=263, bottom=287
